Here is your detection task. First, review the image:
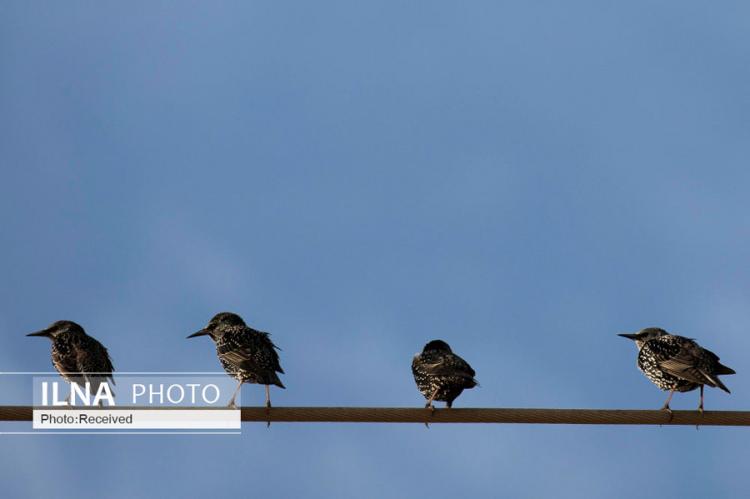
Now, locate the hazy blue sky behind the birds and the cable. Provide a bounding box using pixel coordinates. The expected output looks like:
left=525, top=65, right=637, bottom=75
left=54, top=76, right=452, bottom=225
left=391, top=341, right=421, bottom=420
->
left=0, top=1, right=750, bottom=499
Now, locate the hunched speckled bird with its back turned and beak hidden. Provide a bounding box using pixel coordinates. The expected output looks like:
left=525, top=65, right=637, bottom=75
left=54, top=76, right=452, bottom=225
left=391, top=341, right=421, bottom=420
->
left=411, top=340, right=478, bottom=410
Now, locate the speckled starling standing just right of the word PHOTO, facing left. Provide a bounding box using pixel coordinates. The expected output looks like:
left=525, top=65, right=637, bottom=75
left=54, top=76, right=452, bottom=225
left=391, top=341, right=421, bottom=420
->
left=188, top=312, right=286, bottom=409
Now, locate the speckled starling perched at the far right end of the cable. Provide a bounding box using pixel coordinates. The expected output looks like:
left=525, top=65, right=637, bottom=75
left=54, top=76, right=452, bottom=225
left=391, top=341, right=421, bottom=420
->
left=618, top=327, right=735, bottom=415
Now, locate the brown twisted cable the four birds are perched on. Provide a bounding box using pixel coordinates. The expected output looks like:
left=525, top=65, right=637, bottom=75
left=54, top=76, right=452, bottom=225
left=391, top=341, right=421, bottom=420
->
left=0, top=406, right=750, bottom=426
